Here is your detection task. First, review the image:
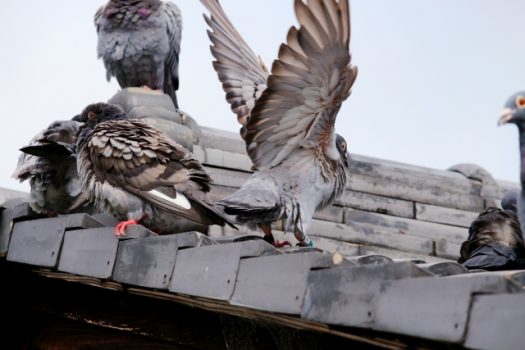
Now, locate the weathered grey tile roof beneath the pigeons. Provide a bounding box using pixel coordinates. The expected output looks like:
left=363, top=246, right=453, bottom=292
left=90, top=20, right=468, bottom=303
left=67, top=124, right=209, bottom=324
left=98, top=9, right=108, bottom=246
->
left=0, top=124, right=525, bottom=349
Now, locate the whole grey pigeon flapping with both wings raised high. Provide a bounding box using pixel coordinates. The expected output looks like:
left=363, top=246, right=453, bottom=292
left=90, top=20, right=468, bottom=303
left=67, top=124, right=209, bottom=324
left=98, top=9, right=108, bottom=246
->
left=201, top=0, right=357, bottom=247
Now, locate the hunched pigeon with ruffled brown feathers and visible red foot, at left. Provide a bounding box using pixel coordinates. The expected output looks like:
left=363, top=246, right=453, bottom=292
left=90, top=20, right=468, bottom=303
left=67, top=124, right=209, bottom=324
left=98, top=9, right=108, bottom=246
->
left=77, top=103, right=233, bottom=236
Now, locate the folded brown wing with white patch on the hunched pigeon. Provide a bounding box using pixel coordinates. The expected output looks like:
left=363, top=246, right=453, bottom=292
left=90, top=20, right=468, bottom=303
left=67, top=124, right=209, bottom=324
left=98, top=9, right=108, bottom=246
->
left=79, top=120, right=226, bottom=224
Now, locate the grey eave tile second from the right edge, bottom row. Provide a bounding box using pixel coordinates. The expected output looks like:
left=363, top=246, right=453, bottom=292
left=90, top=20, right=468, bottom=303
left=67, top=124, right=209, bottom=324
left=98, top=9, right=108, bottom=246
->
left=373, top=274, right=521, bottom=343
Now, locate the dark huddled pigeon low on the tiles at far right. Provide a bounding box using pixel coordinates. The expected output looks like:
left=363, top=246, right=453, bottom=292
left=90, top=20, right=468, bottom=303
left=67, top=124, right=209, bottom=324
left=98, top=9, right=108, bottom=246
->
left=458, top=207, right=525, bottom=270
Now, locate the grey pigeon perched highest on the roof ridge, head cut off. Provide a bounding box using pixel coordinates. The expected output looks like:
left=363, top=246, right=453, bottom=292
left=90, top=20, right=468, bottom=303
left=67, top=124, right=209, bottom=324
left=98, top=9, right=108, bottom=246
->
left=95, top=0, right=182, bottom=108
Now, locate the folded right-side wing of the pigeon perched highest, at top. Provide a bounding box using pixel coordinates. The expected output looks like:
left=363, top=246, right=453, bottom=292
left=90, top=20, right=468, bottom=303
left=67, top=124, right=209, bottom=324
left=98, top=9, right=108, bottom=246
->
left=161, top=2, right=182, bottom=104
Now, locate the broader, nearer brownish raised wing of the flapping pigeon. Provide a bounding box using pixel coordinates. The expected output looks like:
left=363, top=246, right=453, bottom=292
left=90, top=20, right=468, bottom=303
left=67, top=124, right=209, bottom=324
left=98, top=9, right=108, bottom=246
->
left=245, top=0, right=357, bottom=169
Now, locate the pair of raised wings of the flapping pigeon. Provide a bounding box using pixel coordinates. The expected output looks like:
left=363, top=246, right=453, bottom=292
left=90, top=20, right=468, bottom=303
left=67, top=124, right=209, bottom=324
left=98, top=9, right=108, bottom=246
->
left=201, top=0, right=357, bottom=169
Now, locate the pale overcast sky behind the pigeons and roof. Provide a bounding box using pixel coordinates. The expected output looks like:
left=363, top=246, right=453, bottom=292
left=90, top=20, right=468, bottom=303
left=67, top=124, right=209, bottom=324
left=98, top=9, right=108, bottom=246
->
left=0, top=0, right=525, bottom=190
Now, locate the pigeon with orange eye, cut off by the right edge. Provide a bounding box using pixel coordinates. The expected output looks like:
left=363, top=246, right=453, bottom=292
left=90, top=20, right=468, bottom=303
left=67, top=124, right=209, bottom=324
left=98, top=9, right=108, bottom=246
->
left=498, top=91, right=525, bottom=232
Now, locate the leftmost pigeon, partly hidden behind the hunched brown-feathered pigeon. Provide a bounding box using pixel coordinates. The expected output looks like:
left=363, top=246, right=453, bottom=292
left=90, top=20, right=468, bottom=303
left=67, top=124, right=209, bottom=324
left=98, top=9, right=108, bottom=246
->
left=13, top=118, right=81, bottom=216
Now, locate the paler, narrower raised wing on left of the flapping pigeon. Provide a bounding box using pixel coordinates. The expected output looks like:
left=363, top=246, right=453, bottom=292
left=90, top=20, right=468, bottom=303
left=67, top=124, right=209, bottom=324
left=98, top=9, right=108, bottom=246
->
left=201, top=0, right=269, bottom=131
